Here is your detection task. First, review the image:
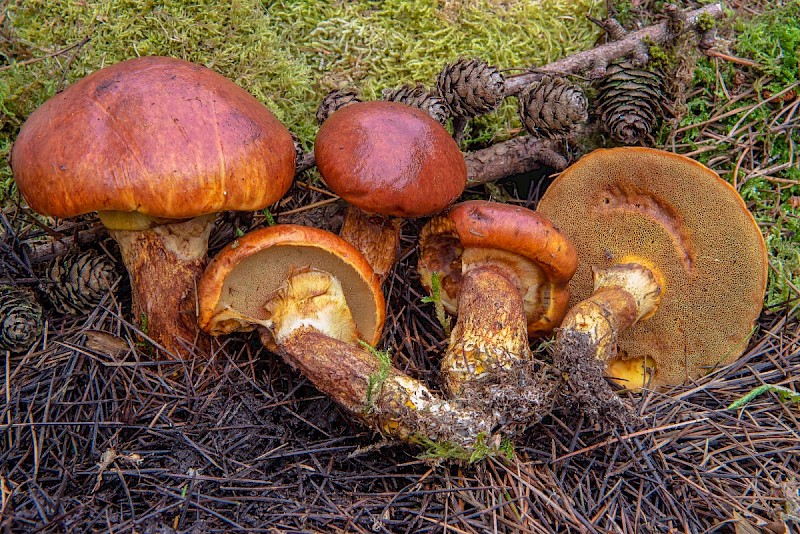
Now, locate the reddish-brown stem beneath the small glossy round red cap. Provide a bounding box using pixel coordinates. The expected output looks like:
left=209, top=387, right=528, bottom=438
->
left=339, top=206, right=402, bottom=282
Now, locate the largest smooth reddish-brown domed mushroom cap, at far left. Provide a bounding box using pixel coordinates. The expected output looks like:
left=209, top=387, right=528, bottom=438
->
left=11, top=57, right=295, bottom=219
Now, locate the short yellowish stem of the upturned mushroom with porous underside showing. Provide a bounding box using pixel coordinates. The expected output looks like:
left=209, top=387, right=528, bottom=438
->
left=558, top=263, right=661, bottom=390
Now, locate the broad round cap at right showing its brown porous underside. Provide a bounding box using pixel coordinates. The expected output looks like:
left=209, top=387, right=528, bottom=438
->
left=537, top=147, right=767, bottom=386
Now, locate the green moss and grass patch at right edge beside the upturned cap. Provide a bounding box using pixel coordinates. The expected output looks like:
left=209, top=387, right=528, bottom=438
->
left=667, top=0, right=800, bottom=307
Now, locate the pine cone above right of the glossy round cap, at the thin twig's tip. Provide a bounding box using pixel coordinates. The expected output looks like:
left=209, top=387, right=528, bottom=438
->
left=436, top=59, right=506, bottom=117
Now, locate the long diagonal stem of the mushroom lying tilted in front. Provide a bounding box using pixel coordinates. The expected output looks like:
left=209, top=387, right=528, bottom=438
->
left=261, top=268, right=495, bottom=449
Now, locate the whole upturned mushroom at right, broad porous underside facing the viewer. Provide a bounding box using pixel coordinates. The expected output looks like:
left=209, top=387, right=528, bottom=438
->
left=537, top=147, right=767, bottom=390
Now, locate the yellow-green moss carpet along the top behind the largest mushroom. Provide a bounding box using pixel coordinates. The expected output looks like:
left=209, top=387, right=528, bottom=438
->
left=0, top=0, right=598, bottom=197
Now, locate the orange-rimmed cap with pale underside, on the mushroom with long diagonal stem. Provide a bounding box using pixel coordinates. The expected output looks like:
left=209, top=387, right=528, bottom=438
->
left=198, top=224, right=386, bottom=345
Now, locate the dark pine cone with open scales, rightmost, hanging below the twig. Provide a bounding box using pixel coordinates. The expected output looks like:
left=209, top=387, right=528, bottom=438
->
left=596, top=62, right=664, bottom=145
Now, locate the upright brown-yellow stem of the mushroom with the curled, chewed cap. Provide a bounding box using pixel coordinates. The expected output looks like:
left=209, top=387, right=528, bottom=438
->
left=442, top=263, right=531, bottom=395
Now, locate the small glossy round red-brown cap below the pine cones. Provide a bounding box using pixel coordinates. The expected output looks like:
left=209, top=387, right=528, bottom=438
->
left=314, top=101, right=467, bottom=217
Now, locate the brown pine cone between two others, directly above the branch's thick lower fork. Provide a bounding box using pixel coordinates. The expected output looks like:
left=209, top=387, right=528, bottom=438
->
left=519, top=75, right=589, bottom=139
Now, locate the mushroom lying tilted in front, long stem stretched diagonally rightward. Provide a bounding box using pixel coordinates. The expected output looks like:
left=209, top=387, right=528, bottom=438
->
left=198, top=225, right=494, bottom=448
